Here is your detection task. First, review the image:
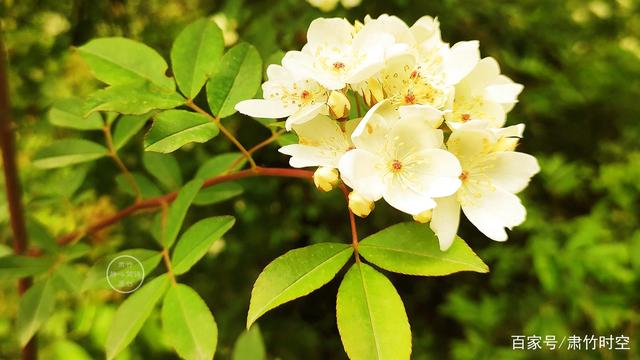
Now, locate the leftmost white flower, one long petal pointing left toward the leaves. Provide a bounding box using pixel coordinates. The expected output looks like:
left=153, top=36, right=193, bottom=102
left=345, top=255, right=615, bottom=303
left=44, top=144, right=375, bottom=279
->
left=236, top=65, right=329, bottom=130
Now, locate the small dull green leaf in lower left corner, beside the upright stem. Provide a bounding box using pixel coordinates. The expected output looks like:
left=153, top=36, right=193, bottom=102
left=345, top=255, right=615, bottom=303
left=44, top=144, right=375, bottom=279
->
left=16, top=280, right=55, bottom=347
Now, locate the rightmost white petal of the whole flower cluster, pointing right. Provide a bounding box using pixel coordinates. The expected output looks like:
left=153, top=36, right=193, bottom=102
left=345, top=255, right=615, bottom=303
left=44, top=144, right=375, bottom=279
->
left=485, top=151, right=540, bottom=193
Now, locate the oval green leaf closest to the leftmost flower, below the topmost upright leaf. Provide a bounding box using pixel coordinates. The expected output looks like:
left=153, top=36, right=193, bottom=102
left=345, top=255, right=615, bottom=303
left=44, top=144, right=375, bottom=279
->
left=207, top=43, right=262, bottom=118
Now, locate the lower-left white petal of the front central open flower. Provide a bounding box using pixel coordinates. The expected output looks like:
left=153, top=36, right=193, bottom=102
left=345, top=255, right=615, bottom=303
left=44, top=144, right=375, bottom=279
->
left=338, top=149, right=384, bottom=201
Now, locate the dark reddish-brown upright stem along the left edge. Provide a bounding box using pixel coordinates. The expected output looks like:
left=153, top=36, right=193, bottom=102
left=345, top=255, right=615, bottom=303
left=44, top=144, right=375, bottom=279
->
left=0, top=32, right=38, bottom=360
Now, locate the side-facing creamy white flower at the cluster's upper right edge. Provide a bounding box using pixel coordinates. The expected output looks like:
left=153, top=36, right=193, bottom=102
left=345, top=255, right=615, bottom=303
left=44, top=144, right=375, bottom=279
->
left=446, top=57, right=523, bottom=128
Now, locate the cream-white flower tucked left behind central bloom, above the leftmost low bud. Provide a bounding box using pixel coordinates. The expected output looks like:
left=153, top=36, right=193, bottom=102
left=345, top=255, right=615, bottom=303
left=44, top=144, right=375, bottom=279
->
left=279, top=115, right=360, bottom=168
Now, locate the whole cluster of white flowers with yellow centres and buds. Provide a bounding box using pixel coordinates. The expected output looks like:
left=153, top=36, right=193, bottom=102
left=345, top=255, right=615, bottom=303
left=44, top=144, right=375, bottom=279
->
left=236, top=15, right=539, bottom=250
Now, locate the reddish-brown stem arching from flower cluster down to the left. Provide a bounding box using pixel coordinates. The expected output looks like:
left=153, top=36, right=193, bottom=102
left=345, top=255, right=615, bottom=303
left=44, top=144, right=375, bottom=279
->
left=58, top=167, right=313, bottom=245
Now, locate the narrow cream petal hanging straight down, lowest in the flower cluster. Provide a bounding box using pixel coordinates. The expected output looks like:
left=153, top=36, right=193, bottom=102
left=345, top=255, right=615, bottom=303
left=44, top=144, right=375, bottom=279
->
left=429, top=195, right=460, bottom=251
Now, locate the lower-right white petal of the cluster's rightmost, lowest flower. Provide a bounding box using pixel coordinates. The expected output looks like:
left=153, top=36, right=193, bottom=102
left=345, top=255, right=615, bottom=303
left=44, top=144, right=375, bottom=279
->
left=462, top=187, right=527, bottom=241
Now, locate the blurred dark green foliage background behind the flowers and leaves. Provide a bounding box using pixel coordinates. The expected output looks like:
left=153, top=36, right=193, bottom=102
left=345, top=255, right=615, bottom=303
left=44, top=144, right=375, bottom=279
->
left=0, top=0, right=640, bottom=360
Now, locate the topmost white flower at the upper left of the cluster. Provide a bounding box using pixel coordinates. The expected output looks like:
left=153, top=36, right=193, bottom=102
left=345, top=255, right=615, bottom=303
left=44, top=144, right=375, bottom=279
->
left=282, top=18, right=393, bottom=90
